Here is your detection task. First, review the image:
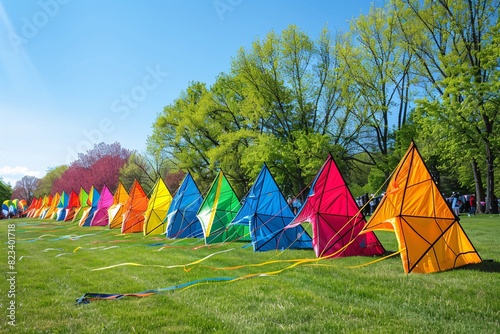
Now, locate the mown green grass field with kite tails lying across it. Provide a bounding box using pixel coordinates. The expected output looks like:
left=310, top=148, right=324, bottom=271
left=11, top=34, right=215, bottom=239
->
left=0, top=215, right=500, bottom=333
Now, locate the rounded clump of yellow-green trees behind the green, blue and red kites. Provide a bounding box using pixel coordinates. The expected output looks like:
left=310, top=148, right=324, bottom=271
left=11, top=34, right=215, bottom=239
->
left=150, top=25, right=356, bottom=196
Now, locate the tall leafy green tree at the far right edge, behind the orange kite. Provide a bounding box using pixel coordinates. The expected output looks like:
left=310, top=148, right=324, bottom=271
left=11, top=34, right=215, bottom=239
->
left=393, top=0, right=500, bottom=212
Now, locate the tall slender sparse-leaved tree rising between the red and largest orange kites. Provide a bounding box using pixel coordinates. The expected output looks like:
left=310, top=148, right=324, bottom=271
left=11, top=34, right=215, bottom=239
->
left=338, top=6, right=414, bottom=191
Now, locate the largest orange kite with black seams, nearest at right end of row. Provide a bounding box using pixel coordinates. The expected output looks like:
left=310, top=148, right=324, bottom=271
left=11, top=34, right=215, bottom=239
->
left=365, top=142, right=482, bottom=273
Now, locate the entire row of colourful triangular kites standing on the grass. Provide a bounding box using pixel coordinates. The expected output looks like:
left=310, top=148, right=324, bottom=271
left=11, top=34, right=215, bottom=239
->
left=19, top=143, right=482, bottom=273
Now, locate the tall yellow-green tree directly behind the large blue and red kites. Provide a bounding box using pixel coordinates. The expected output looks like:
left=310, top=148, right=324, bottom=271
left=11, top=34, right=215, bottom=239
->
left=231, top=25, right=357, bottom=197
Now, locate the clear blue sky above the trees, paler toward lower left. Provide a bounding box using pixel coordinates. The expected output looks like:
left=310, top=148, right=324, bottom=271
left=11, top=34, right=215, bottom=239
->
left=0, top=0, right=383, bottom=185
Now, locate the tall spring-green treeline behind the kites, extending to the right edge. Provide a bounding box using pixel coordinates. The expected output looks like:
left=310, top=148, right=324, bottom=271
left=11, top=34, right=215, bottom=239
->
left=148, top=0, right=500, bottom=211
